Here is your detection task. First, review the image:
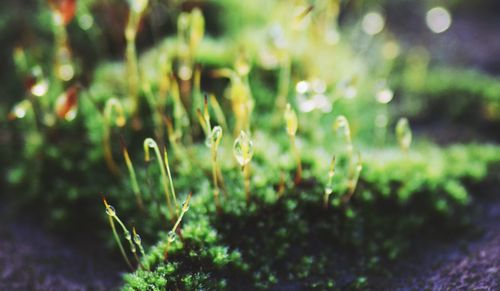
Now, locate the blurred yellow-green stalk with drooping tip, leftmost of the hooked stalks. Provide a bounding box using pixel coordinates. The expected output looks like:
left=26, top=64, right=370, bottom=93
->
left=103, top=98, right=126, bottom=176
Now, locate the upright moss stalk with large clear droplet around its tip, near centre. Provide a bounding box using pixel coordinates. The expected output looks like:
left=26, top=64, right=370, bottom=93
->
left=233, top=130, right=254, bottom=204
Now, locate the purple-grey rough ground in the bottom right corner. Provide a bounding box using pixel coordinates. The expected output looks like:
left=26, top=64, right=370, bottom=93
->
left=367, top=188, right=500, bottom=291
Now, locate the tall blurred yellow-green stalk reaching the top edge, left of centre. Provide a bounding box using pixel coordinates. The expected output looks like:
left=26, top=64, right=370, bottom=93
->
left=125, top=0, right=148, bottom=115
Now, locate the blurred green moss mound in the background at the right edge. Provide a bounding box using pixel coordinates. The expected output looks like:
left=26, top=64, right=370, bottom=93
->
left=391, top=67, right=500, bottom=127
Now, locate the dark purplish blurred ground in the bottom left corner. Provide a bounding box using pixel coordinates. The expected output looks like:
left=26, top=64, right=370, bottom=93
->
left=0, top=203, right=126, bottom=290
